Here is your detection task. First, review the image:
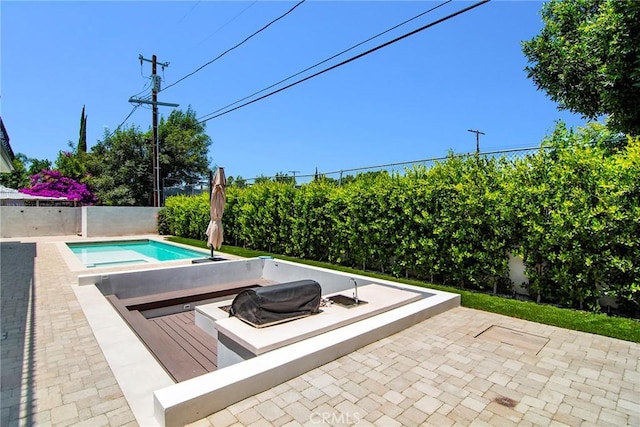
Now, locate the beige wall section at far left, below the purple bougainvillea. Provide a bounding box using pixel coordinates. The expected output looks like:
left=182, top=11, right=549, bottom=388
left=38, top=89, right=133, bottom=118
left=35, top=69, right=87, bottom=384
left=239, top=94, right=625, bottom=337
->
left=0, top=206, right=81, bottom=237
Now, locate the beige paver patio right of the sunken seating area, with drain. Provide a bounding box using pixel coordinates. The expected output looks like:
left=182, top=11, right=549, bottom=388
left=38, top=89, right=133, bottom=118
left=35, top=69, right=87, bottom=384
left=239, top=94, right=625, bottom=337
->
left=192, top=308, right=640, bottom=427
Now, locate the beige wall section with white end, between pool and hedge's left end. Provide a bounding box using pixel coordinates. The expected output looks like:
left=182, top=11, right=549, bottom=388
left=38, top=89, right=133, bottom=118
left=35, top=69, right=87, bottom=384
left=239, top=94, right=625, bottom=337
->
left=82, top=206, right=160, bottom=237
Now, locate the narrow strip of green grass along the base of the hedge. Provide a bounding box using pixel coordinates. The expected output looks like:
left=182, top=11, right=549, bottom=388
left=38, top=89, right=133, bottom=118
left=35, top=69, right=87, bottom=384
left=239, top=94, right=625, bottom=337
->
left=167, top=237, right=640, bottom=342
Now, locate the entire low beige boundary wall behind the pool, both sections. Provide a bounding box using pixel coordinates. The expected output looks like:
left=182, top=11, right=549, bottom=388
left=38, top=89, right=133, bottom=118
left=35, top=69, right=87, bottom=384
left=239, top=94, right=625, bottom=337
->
left=0, top=206, right=160, bottom=238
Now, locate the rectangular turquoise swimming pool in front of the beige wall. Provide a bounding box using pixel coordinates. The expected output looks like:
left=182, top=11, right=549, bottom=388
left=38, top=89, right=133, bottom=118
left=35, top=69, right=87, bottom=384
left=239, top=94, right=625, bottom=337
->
left=67, top=239, right=206, bottom=268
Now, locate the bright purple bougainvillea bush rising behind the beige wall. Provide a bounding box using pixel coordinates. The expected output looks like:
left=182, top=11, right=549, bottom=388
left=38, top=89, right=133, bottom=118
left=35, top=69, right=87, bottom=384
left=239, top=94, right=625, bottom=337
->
left=19, top=170, right=96, bottom=205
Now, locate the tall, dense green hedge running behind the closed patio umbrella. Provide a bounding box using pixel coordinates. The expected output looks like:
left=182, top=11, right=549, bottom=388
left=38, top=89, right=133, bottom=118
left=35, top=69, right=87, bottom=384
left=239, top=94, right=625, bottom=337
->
left=160, top=124, right=640, bottom=316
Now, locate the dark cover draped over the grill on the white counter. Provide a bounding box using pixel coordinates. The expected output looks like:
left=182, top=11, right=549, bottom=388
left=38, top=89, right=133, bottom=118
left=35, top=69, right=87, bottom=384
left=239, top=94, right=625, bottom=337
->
left=229, top=280, right=321, bottom=328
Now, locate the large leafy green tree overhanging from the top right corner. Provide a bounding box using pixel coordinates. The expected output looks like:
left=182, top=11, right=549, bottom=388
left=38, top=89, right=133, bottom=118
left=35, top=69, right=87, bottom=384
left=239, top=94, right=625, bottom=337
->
left=522, top=0, right=640, bottom=135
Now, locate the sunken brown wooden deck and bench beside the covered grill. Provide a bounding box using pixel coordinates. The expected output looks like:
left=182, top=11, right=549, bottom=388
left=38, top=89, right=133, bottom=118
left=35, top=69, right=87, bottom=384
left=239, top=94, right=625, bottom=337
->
left=106, top=280, right=273, bottom=382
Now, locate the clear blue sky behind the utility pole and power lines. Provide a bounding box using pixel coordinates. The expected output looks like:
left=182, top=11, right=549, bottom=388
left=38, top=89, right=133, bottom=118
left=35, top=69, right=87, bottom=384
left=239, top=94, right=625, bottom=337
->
left=0, top=0, right=584, bottom=182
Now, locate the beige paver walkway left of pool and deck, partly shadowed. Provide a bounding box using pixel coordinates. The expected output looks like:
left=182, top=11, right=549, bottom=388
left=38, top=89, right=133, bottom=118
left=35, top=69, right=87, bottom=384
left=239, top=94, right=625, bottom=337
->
left=0, top=242, right=137, bottom=426
